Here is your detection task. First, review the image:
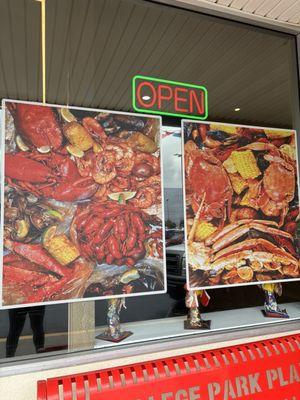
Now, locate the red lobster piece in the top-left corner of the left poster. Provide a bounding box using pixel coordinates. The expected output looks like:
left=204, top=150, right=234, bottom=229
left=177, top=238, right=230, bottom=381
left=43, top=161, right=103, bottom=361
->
left=7, top=103, right=63, bottom=150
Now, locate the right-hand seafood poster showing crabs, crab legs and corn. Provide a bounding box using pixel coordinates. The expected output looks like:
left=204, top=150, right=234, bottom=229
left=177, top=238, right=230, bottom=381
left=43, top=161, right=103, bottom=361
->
left=182, top=120, right=300, bottom=289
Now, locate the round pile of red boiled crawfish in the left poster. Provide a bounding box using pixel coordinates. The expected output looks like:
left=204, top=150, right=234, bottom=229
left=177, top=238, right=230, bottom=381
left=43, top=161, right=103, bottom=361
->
left=70, top=201, right=162, bottom=266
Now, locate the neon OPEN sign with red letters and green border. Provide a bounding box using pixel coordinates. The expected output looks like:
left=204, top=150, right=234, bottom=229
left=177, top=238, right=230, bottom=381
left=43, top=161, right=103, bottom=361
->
left=132, top=75, right=208, bottom=120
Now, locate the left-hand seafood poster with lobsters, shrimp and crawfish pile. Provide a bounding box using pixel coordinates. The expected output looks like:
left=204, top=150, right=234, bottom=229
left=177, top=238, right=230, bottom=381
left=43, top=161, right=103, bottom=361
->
left=1, top=100, right=166, bottom=308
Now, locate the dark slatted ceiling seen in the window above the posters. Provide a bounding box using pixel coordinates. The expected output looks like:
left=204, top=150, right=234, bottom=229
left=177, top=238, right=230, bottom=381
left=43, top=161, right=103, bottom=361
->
left=0, top=0, right=296, bottom=127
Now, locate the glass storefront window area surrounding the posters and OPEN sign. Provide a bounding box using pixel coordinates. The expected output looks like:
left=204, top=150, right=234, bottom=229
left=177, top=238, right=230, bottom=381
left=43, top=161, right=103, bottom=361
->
left=0, top=0, right=300, bottom=362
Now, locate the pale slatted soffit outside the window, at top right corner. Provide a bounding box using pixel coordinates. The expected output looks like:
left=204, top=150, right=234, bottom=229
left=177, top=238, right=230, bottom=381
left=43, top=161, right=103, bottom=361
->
left=205, top=0, right=300, bottom=25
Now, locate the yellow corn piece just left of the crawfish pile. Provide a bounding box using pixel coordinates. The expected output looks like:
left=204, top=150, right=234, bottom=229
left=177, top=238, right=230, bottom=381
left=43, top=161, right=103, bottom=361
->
left=44, top=234, right=80, bottom=265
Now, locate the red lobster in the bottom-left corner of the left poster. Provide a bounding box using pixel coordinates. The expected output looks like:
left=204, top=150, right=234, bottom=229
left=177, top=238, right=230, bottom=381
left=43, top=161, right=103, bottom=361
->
left=3, top=241, right=92, bottom=304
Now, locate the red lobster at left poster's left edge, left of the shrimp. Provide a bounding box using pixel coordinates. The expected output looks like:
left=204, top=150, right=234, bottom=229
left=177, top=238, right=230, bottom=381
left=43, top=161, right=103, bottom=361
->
left=5, top=151, right=98, bottom=202
